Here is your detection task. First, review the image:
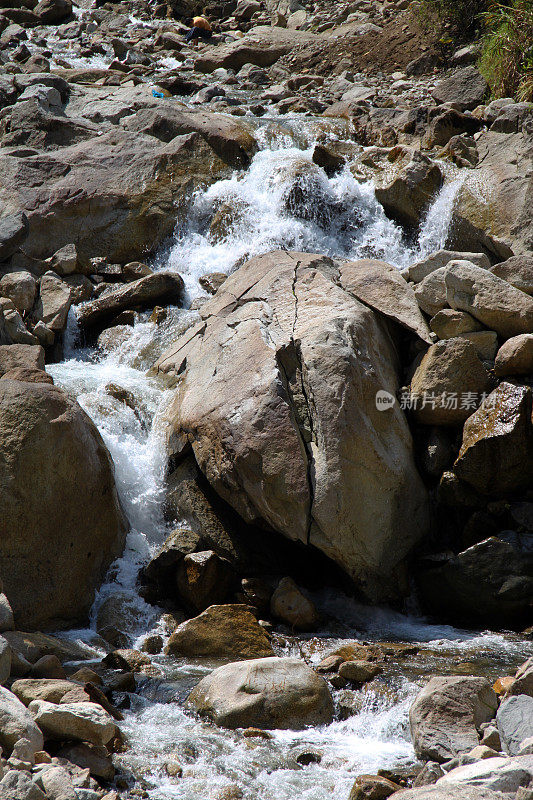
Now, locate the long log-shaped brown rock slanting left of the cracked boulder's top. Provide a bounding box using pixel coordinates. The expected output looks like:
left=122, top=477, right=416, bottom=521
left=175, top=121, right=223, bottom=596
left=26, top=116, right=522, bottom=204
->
left=78, top=272, right=183, bottom=328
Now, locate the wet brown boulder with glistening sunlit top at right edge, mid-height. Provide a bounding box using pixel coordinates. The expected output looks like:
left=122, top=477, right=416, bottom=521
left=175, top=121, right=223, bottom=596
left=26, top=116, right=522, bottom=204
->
left=454, top=382, right=533, bottom=495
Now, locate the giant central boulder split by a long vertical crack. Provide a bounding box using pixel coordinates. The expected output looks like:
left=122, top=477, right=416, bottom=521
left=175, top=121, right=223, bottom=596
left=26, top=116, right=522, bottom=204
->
left=153, top=251, right=427, bottom=601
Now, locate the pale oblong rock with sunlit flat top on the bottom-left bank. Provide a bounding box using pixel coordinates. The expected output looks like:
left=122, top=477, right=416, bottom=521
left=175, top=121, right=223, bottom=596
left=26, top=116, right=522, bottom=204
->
left=29, top=700, right=116, bottom=745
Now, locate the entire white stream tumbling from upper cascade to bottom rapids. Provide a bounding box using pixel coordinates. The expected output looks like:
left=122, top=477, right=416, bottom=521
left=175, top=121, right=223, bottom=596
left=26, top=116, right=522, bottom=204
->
left=47, top=118, right=533, bottom=800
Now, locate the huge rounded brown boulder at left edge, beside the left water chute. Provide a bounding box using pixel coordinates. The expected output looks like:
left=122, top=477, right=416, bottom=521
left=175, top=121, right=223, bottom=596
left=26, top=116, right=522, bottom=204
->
left=0, top=379, right=126, bottom=629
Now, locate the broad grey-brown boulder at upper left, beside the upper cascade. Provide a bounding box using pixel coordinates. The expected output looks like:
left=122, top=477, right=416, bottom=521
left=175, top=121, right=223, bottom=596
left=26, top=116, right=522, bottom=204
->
left=0, top=130, right=229, bottom=263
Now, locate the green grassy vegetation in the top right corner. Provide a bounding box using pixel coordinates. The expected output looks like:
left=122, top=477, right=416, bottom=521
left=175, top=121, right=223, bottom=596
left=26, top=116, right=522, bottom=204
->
left=422, top=0, right=533, bottom=102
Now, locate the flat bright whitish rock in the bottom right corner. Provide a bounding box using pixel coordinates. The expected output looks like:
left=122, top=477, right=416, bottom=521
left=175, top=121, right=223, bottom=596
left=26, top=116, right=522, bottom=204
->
left=437, top=756, right=533, bottom=797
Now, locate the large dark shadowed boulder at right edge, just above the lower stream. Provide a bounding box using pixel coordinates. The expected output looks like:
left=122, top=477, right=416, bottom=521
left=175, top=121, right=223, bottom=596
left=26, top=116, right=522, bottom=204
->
left=416, top=534, right=533, bottom=628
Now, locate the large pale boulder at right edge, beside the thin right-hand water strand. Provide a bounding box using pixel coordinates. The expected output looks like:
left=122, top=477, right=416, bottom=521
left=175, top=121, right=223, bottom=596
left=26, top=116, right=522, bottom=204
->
left=448, top=131, right=533, bottom=261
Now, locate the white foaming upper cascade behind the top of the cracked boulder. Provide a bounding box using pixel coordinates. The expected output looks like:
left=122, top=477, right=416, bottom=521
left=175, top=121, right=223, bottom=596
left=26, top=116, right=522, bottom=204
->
left=158, top=139, right=461, bottom=300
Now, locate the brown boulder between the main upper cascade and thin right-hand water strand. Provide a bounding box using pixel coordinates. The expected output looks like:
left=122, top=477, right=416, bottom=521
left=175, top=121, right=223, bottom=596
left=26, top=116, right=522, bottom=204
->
left=376, top=150, right=443, bottom=226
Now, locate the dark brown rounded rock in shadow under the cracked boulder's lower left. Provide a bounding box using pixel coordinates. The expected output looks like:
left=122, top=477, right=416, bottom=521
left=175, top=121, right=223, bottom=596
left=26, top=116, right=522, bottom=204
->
left=176, top=550, right=235, bottom=611
